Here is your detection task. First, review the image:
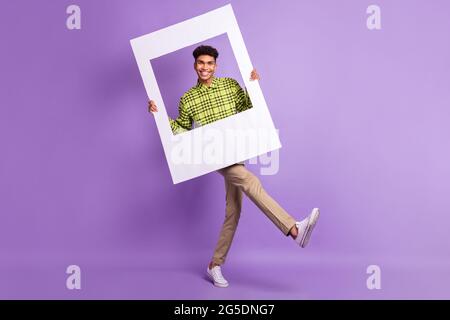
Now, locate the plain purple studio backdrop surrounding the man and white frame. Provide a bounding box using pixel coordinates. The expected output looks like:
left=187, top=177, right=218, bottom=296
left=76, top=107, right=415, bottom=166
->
left=0, top=0, right=450, bottom=299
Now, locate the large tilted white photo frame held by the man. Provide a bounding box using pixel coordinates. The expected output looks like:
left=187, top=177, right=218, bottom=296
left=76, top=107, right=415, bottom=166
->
left=130, top=4, right=281, bottom=184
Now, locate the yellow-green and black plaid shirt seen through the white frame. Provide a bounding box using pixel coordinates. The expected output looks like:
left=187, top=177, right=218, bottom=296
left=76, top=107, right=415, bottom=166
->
left=169, top=78, right=252, bottom=134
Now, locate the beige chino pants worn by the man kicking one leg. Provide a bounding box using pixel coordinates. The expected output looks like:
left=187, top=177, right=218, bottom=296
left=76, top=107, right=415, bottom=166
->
left=213, top=164, right=295, bottom=265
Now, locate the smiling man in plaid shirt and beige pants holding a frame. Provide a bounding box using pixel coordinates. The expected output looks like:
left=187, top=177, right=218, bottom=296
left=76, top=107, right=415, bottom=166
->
left=148, top=46, right=319, bottom=287
